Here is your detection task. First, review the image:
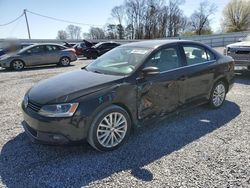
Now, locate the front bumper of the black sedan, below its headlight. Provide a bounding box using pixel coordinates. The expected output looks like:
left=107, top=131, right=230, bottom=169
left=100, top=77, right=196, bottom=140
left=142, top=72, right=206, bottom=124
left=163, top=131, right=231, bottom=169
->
left=22, top=104, right=87, bottom=144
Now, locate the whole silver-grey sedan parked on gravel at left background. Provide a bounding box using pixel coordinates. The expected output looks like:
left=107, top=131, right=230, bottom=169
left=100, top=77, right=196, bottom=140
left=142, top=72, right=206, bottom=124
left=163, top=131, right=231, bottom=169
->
left=0, top=44, right=77, bottom=70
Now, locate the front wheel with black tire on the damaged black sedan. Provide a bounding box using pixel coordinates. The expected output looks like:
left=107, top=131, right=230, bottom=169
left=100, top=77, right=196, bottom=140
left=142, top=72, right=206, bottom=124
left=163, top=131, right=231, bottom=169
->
left=87, top=105, right=131, bottom=151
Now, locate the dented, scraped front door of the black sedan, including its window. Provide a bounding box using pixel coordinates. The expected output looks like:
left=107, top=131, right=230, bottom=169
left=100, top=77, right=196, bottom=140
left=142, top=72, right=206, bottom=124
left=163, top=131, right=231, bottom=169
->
left=137, top=45, right=182, bottom=119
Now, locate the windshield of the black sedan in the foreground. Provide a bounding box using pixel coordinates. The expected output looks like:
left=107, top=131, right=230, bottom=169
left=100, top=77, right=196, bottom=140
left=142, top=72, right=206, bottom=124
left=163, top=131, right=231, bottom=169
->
left=86, top=47, right=151, bottom=76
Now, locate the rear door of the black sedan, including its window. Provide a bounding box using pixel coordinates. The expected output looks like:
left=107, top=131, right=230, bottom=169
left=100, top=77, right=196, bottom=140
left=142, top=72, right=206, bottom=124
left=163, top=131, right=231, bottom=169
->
left=180, top=43, right=216, bottom=104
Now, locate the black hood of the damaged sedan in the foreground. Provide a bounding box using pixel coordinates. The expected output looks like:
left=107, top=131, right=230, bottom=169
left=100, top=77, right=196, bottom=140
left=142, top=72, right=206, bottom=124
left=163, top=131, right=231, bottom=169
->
left=28, top=69, right=124, bottom=105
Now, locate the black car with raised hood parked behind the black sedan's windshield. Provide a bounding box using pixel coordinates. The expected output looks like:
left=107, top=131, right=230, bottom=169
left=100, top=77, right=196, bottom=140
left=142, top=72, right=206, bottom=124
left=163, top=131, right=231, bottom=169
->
left=83, top=42, right=120, bottom=59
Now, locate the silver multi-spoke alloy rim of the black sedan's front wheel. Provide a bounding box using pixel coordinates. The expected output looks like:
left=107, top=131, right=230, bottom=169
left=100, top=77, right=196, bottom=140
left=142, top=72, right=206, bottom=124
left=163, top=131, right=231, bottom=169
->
left=97, top=112, right=128, bottom=148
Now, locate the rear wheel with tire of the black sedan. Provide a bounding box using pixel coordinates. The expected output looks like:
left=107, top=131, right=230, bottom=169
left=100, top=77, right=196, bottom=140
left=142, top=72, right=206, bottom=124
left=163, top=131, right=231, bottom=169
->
left=209, top=81, right=227, bottom=109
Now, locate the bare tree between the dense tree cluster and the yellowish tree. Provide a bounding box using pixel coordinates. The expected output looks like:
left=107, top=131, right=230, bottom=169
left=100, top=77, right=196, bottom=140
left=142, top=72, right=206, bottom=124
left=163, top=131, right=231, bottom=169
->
left=190, top=1, right=216, bottom=35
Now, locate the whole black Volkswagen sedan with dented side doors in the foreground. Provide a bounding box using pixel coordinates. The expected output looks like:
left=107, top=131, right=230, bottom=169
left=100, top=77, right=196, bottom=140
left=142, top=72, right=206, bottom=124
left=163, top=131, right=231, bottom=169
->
left=22, top=40, right=234, bottom=151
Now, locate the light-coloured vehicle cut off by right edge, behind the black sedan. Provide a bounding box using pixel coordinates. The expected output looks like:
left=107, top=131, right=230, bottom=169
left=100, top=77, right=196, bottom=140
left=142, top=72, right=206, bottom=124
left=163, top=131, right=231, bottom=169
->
left=224, top=36, right=250, bottom=70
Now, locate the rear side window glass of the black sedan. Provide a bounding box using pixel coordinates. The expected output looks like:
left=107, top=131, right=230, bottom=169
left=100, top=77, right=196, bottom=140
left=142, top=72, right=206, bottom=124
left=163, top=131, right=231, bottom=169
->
left=183, top=45, right=215, bottom=65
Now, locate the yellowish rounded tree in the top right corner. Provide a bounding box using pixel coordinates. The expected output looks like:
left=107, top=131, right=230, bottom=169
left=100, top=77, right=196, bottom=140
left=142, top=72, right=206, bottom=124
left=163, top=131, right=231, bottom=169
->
left=223, top=0, right=250, bottom=32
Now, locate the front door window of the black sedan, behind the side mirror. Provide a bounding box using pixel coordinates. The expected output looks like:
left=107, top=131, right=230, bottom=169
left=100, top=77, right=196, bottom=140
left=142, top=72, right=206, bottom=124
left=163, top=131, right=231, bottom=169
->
left=145, top=48, right=181, bottom=72
